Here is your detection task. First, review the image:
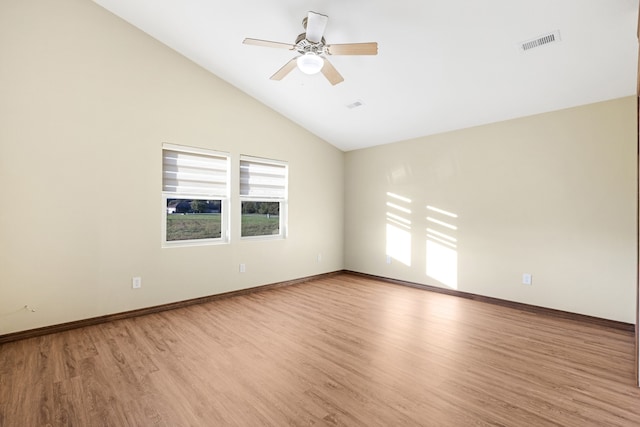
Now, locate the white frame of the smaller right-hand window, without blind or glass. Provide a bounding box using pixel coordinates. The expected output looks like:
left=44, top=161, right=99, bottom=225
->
left=238, top=155, right=289, bottom=240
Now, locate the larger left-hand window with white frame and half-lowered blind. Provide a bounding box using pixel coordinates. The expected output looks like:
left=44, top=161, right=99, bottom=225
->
left=162, top=144, right=229, bottom=246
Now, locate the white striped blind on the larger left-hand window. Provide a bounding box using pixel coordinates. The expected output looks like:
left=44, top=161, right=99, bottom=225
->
left=162, top=149, right=229, bottom=197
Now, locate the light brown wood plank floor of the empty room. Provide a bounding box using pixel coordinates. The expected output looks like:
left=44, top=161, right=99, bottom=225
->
left=0, top=274, right=640, bottom=427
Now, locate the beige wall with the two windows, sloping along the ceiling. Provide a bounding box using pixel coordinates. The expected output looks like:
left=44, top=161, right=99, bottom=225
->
left=0, top=0, right=344, bottom=334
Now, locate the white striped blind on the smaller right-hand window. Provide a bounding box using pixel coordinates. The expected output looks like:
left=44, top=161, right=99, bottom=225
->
left=240, top=158, right=287, bottom=200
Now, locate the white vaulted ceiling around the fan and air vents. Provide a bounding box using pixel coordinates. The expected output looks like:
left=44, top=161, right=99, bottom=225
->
left=94, top=0, right=638, bottom=151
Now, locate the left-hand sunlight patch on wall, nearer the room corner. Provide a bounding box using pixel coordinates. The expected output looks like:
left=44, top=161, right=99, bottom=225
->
left=386, top=193, right=411, bottom=267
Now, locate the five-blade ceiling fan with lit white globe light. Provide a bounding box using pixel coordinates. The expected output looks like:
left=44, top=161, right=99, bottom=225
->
left=243, top=12, right=378, bottom=85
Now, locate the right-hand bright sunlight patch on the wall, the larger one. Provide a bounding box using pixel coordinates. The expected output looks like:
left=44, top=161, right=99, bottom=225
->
left=426, top=206, right=458, bottom=289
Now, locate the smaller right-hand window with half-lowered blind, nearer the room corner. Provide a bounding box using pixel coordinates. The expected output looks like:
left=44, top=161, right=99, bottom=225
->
left=240, top=156, right=288, bottom=238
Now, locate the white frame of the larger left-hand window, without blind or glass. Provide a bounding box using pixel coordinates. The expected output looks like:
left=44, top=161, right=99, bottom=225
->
left=161, top=143, right=231, bottom=248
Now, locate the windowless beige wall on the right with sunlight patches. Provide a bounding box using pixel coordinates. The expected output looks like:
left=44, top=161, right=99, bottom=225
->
left=345, top=97, right=636, bottom=323
